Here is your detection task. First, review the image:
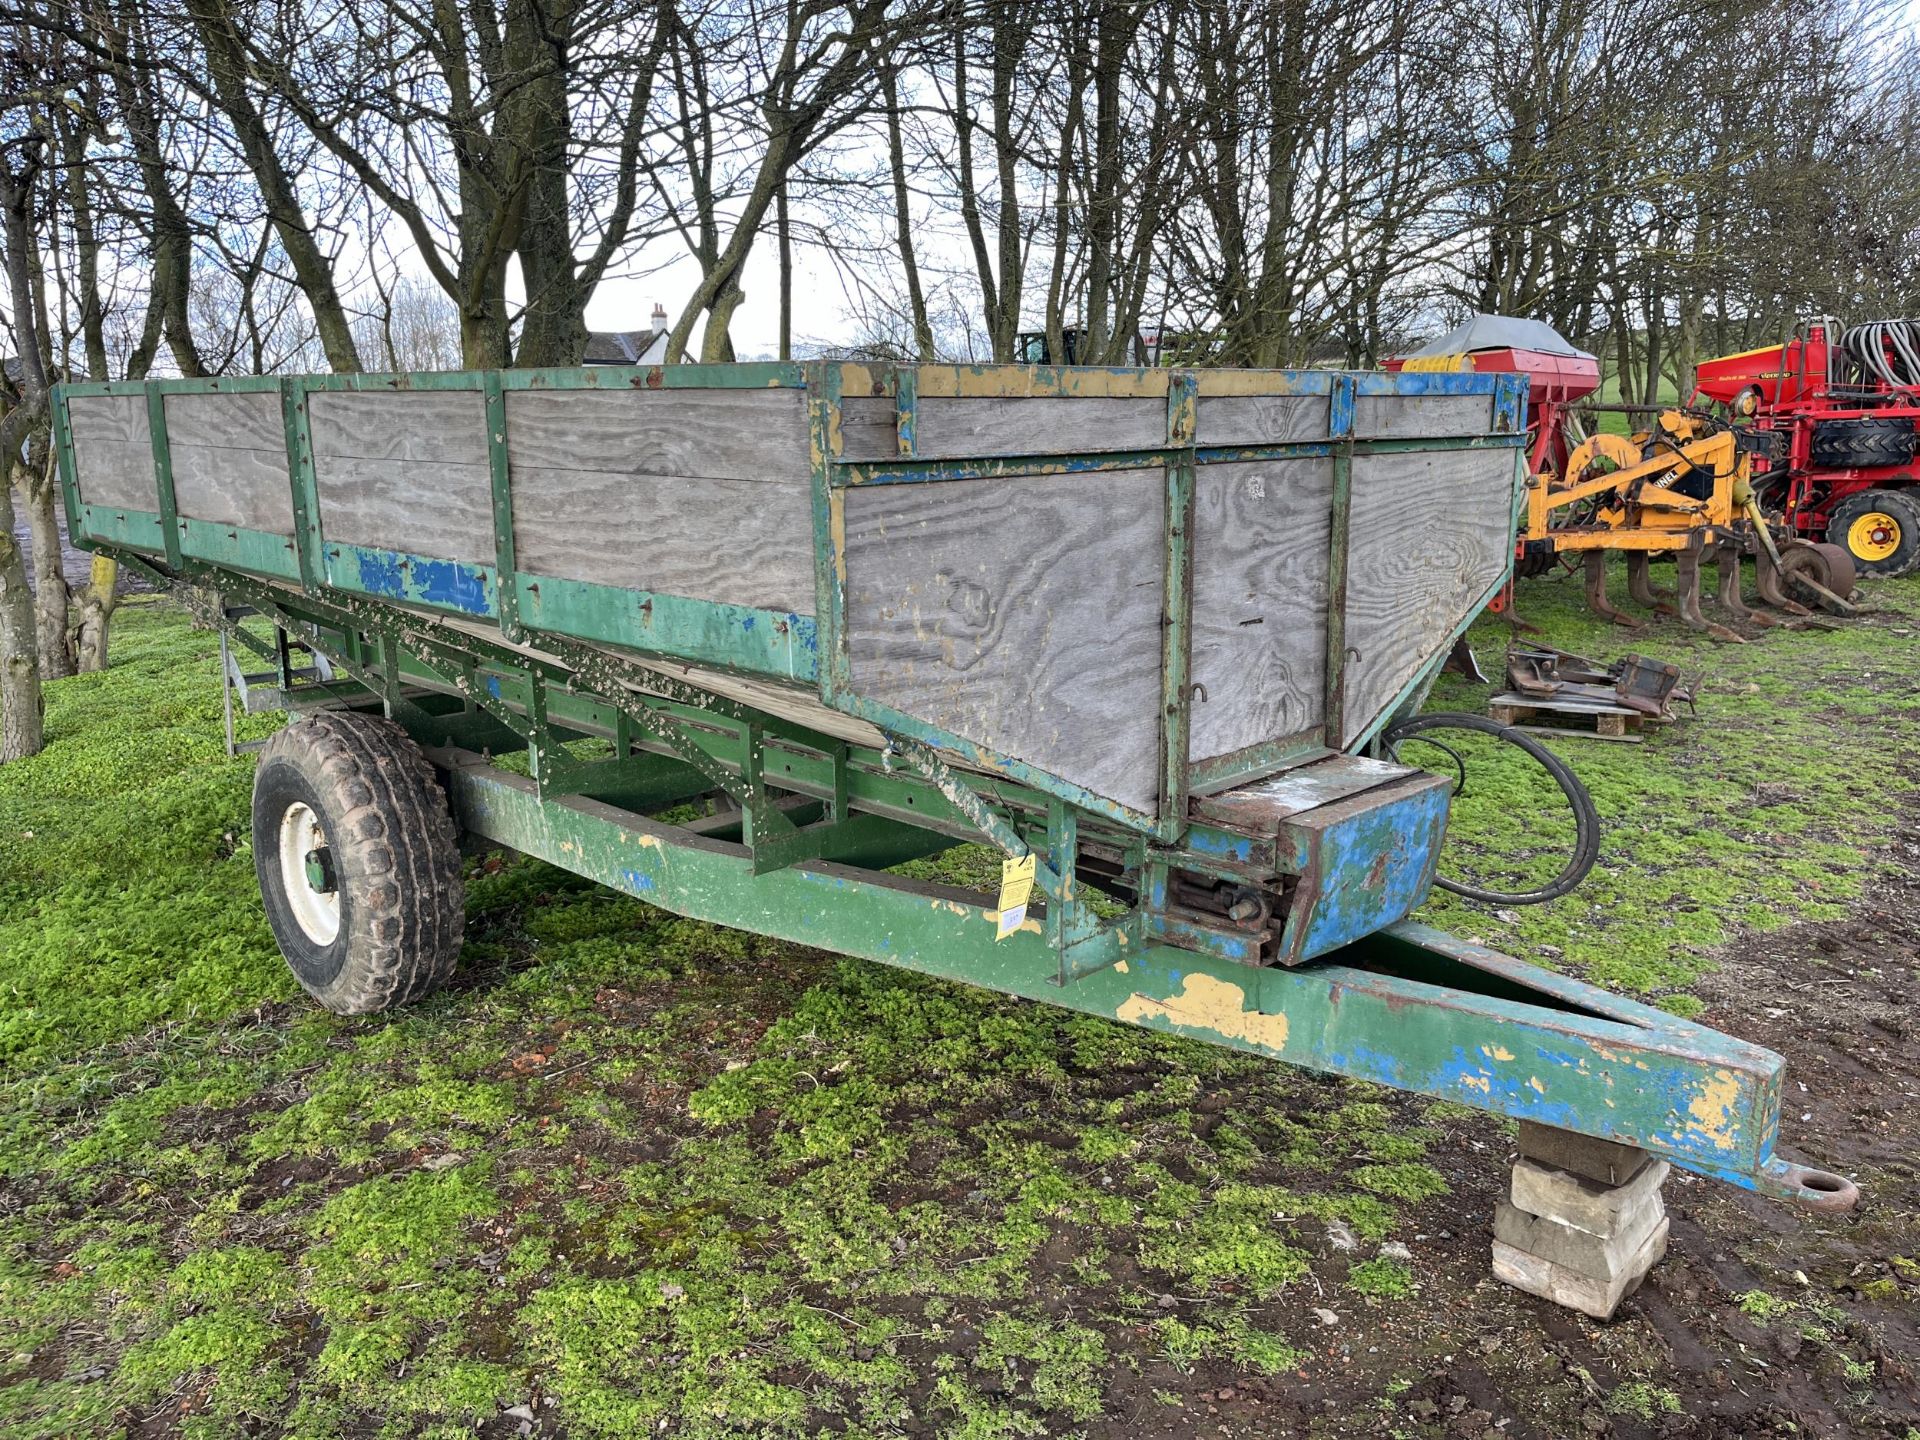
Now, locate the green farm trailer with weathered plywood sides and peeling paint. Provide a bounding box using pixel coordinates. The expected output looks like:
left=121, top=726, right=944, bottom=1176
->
left=54, top=363, right=1855, bottom=1244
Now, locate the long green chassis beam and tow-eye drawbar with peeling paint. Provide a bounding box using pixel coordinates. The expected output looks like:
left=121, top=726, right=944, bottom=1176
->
left=428, top=749, right=1857, bottom=1210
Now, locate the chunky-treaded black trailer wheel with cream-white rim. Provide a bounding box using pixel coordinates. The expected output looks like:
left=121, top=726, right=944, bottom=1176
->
left=253, top=710, right=467, bottom=1016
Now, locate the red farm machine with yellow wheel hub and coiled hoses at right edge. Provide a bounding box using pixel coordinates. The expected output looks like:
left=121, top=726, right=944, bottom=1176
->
left=1693, top=319, right=1920, bottom=576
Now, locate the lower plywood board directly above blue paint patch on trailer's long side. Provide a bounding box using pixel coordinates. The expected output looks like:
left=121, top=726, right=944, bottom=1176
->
left=313, top=455, right=495, bottom=564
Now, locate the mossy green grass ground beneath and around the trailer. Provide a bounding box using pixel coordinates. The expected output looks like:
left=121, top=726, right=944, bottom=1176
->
left=11, top=580, right=1920, bottom=1440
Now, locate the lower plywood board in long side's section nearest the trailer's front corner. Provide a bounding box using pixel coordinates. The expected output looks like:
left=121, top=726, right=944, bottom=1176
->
left=513, top=467, right=814, bottom=614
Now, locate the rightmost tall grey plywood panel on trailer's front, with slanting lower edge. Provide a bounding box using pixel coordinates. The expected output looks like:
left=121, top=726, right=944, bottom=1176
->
left=1340, top=449, right=1515, bottom=747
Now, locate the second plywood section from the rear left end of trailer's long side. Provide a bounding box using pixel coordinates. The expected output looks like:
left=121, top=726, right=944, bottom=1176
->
left=165, top=392, right=294, bottom=536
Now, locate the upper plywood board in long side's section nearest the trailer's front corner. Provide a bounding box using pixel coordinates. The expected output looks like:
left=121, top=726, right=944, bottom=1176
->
left=507, top=390, right=806, bottom=480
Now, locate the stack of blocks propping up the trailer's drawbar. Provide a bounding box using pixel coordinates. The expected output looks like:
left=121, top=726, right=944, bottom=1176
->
left=1494, top=1121, right=1667, bottom=1319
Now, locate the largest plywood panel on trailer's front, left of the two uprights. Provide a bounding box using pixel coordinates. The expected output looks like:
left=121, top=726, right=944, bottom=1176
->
left=847, top=468, right=1165, bottom=810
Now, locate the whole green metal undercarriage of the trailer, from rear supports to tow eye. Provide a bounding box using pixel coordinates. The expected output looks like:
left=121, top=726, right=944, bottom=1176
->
left=86, top=503, right=1851, bottom=1208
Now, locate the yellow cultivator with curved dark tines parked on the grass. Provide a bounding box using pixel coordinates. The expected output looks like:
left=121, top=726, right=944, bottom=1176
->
left=1517, top=409, right=1853, bottom=639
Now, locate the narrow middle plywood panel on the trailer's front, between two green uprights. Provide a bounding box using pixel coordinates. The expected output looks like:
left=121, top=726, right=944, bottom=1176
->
left=1187, top=458, right=1332, bottom=760
